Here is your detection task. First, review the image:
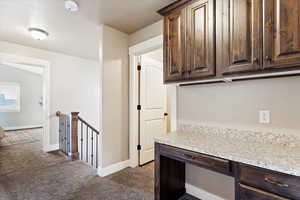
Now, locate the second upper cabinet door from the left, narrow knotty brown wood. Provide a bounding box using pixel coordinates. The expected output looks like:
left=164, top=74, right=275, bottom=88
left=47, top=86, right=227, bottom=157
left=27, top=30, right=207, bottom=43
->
left=186, top=0, right=216, bottom=79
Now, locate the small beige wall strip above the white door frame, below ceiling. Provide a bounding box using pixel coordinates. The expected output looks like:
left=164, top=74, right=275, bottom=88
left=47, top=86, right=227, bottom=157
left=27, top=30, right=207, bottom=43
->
left=129, top=20, right=163, bottom=46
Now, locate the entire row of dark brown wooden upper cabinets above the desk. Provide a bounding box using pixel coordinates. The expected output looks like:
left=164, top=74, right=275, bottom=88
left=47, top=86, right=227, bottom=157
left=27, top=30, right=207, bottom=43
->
left=158, top=0, right=300, bottom=83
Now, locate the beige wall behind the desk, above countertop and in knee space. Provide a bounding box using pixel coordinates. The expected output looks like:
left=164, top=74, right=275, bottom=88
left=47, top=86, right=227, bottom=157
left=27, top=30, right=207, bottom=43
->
left=178, top=77, right=300, bottom=200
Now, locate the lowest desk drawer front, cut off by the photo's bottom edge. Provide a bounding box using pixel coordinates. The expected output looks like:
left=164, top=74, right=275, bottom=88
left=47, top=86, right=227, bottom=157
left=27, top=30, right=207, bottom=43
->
left=239, top=185, right=289, bottom=200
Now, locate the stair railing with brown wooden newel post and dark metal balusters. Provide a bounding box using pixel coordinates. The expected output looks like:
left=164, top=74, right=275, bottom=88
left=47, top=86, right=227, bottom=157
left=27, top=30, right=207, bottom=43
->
left=56, top=111, right=100, bottom=168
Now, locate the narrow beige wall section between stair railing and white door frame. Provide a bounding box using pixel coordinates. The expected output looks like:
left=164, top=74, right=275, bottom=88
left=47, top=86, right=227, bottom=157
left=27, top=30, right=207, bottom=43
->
left=100, top=25, right=129, bottom=167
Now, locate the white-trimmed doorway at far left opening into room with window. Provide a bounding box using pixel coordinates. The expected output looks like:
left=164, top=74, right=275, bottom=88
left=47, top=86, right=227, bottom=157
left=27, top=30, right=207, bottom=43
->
left=0, top=53, right=51, bottom=152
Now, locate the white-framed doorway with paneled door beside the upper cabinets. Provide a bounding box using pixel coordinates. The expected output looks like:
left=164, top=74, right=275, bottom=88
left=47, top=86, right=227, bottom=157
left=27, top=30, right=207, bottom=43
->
left=129, top=35, right=177, bottom=167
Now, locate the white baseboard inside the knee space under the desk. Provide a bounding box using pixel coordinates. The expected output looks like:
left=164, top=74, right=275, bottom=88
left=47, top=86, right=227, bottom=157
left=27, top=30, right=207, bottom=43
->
left=185, top=183, right=225, bottom=200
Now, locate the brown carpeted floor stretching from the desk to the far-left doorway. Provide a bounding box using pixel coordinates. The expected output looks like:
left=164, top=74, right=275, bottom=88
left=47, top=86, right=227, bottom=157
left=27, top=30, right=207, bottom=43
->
left=0, top=132, right=154, bottom=200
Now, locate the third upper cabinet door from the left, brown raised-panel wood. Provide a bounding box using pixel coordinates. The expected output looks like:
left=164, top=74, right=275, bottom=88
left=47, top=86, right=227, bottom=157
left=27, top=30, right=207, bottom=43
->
left=217, top=0, right=262, bottom=75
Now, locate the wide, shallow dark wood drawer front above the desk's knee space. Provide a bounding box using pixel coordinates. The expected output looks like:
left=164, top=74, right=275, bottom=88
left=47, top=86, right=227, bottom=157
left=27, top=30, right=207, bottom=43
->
left=160, top=145, right=232, bottom=175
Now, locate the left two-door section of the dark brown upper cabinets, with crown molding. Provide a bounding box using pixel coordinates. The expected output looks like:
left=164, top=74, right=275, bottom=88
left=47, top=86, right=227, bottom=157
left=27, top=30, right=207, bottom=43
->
left=159, top=0, right=216, bottom=83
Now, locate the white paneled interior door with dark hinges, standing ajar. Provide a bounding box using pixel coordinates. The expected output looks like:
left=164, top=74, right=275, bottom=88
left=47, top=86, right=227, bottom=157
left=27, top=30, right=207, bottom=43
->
left=139, top=56, right=167, bottom=165
